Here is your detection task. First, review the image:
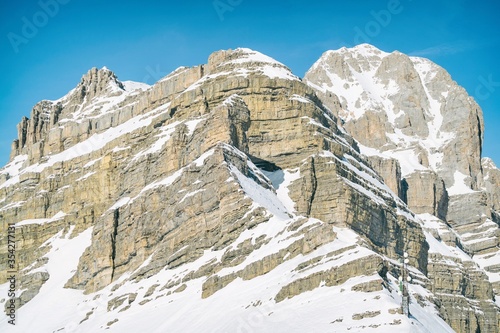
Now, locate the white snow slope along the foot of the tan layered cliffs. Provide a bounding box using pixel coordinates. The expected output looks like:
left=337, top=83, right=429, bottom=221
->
left=0, top=220, right=453, bottom=333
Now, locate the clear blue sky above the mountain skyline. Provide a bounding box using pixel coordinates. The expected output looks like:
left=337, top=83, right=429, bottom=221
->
left=0, top=0, right=500, bottom=165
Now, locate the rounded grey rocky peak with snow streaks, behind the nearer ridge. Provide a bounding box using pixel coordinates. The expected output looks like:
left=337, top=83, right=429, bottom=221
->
left=304, top=44, right=484, bottom=189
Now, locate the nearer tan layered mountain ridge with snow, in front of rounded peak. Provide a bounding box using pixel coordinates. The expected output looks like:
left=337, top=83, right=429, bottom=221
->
left=0, top=45, right=500, bottom=332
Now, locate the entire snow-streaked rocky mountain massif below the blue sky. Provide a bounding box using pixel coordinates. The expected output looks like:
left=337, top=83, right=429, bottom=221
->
left=0, top=45, right=500, bottom=332
